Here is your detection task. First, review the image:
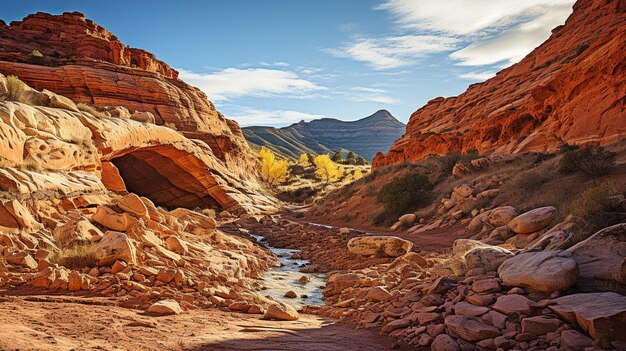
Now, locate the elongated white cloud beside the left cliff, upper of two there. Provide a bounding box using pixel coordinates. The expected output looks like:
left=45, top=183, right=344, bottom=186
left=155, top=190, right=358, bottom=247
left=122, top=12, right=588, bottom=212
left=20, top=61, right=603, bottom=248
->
left=179, top=67, right=327, bottom=101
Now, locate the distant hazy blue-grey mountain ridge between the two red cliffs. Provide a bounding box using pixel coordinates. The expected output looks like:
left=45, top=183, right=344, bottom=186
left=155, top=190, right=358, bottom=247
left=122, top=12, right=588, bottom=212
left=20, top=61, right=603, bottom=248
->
left=243, top=110, right=405, bottom=161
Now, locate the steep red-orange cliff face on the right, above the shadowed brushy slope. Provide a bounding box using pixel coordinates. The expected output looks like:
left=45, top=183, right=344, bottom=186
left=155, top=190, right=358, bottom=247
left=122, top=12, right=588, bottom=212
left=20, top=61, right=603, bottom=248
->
left=373, top=0, right=626, bottom=167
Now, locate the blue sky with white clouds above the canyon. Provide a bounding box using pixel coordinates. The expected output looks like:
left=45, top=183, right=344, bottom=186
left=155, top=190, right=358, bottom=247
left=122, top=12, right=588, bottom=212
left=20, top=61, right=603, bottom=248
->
left=0, top=0, right=574, bottom=126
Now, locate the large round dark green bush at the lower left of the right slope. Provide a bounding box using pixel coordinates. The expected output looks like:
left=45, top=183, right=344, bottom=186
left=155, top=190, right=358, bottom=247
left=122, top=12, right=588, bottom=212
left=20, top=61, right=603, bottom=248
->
left=377, top=173, right=433, bottom=220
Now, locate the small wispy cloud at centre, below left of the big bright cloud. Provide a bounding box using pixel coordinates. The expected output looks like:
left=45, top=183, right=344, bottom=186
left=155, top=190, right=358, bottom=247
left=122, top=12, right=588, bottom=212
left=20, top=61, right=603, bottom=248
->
left=326, top=35, right=458, bottom=70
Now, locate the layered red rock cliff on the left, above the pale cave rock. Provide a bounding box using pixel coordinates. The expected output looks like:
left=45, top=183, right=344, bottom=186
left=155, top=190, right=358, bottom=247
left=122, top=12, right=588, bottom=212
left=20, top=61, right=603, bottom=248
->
left=0, top=12, right=256, bottom=177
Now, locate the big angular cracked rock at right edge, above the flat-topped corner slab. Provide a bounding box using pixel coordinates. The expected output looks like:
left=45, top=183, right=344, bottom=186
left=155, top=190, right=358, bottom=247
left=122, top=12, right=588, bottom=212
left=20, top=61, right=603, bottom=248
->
left=567, top=223, right=626, bottom=290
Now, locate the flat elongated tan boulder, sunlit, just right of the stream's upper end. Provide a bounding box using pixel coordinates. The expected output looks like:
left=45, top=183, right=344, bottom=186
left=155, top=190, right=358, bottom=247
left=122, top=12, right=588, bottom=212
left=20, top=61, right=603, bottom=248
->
left=348, top=236, right=413, bottom=257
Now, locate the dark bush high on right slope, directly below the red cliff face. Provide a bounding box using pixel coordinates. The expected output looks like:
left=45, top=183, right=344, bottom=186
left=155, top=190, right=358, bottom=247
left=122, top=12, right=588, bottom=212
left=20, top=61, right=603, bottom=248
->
left=559, top=147, right=617, bottom=177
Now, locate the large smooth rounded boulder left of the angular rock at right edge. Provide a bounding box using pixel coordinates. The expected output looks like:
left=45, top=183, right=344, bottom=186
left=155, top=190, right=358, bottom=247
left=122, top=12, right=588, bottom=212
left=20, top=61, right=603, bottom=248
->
left=498, top=251, right=578, bottom=293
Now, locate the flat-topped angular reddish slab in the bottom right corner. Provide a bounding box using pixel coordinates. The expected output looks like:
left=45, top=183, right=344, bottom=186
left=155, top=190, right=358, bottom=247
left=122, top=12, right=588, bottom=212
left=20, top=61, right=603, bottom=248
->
left=548, top=292, right=626, bottom=341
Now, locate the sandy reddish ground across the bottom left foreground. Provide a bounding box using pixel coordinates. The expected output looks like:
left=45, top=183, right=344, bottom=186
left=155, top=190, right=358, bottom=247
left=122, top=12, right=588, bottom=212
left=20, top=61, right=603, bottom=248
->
left=0, top=295, right=403, bottom=351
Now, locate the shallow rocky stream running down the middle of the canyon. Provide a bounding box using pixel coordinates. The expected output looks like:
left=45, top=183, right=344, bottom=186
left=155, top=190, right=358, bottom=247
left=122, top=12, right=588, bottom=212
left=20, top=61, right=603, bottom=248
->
left=250, top=234, right=326, bottom=309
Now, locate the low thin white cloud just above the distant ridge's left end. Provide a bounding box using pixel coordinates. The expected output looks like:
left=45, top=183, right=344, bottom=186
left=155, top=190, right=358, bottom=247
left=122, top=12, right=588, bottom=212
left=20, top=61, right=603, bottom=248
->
left=228, top=108, right=327, bottom=127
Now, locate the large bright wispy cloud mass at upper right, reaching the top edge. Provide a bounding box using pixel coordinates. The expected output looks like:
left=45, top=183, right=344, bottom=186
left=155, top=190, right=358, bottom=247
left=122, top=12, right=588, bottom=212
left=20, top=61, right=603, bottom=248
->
left=326, top=0, right=575, bottom=70
